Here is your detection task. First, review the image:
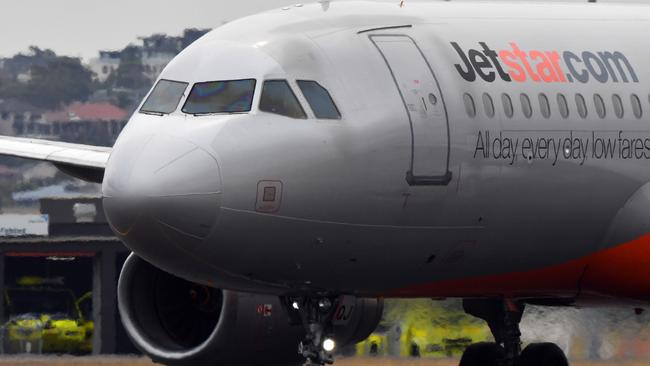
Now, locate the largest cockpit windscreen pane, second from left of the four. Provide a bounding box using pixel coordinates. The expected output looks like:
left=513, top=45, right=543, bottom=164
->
left=183, top=79, right=255, bottom=115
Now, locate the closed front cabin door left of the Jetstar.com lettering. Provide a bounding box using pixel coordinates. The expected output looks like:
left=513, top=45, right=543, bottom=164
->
left=370, top=35, right=451, bottom=185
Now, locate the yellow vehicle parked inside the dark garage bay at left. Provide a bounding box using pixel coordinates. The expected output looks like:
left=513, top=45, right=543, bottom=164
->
left=4, top=287, right=94, bottom=354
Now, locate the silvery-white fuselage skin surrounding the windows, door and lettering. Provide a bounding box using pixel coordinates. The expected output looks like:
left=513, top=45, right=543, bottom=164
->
left=103, top=2, right=650, bottom=297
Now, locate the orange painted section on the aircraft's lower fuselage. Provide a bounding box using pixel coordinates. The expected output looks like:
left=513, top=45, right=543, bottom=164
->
left=386, top=234, right=650, bottom=301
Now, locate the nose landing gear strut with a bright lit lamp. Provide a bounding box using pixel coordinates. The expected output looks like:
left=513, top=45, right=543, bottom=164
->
left=289, top=297, right=339, bottom=366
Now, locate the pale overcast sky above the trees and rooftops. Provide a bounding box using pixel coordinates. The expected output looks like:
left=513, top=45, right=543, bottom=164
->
left=0, top=0, right=650, bottom=60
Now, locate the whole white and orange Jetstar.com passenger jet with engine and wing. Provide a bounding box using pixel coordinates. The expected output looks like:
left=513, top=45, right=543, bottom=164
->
left=0, top=1, right=650, bottom=366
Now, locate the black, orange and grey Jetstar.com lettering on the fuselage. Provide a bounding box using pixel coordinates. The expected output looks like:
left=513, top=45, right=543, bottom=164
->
left=451, top=42, right=639, bottom=83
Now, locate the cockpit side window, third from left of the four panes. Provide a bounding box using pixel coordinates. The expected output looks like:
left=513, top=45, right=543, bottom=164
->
left=260, top=80, right=307, bottom=119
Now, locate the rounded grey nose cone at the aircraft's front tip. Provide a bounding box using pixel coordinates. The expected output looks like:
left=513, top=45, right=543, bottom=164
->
left=102, top=136, right=221, bottom=243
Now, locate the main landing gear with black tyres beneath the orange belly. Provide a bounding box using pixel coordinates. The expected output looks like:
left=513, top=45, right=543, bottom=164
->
left=460, top=299, right=569, bottom=366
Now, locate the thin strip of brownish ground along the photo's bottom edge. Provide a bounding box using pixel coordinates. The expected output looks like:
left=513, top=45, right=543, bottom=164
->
left=0, top=356, right=650, bottom=366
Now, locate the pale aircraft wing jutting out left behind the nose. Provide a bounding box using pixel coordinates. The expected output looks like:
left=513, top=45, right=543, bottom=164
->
left=0, top=136, right=112, bottom=183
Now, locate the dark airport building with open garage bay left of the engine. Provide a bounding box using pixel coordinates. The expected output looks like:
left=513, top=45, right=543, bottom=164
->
left=0, top=197, right=136, bottom=354
